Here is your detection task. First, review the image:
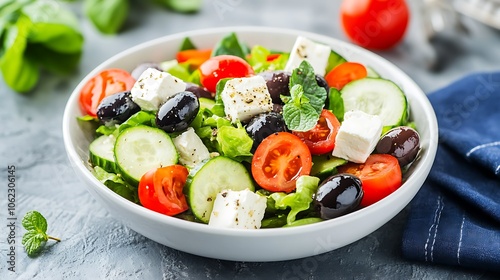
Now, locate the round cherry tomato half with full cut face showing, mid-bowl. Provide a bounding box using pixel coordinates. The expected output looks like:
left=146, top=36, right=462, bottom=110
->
left=252, top=132, right=312, bottom=192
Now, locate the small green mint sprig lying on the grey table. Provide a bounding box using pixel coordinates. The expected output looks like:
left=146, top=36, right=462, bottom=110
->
left=21, top=211, right=61, bottom=257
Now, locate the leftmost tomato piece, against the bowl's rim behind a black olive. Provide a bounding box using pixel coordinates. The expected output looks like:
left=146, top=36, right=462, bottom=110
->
left=80, top=69, right=135, bottom=117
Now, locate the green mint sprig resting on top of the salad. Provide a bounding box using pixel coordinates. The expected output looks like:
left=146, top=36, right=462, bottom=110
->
left=282, top=60, right=326, bottom=131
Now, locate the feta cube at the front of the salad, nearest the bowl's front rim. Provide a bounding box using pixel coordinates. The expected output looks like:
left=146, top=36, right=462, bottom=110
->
left=208, top=189, right=267, bottom=229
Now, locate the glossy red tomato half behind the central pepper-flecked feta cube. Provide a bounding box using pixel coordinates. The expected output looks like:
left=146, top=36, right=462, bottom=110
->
left=198, top=55, right=254, bottom=92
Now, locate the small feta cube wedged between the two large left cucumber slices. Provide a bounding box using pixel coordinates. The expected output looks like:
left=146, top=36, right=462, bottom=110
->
left=173, top=127, right=210, bottom=167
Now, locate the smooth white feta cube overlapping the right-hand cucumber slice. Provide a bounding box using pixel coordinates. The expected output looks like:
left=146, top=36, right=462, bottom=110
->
left=332, top=111, right=382, bottom=163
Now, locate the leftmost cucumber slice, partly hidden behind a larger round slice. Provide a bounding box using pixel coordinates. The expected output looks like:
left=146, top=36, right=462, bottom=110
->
left=89, top=135, right=117, bottom=173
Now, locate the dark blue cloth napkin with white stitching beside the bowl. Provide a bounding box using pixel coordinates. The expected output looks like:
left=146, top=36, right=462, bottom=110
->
left=402, top=72, right=500, bottom=271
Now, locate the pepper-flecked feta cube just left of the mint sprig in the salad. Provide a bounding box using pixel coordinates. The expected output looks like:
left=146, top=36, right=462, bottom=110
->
left=221, top=76, right=273, bottom=123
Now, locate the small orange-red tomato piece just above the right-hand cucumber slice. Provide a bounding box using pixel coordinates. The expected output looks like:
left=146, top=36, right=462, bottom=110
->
left=325, top=62, right=368, bottom=90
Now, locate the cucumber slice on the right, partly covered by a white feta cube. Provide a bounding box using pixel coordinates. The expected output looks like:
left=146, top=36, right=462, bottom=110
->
left=340, top=78, right=407, bottom=126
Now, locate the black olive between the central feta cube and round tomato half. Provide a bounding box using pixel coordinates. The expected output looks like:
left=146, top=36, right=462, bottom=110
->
left=246, top=112, right=286, bottom=152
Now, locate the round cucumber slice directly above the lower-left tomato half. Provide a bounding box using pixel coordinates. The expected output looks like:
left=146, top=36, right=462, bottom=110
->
left=114, top=125, right=179, bottom=185
